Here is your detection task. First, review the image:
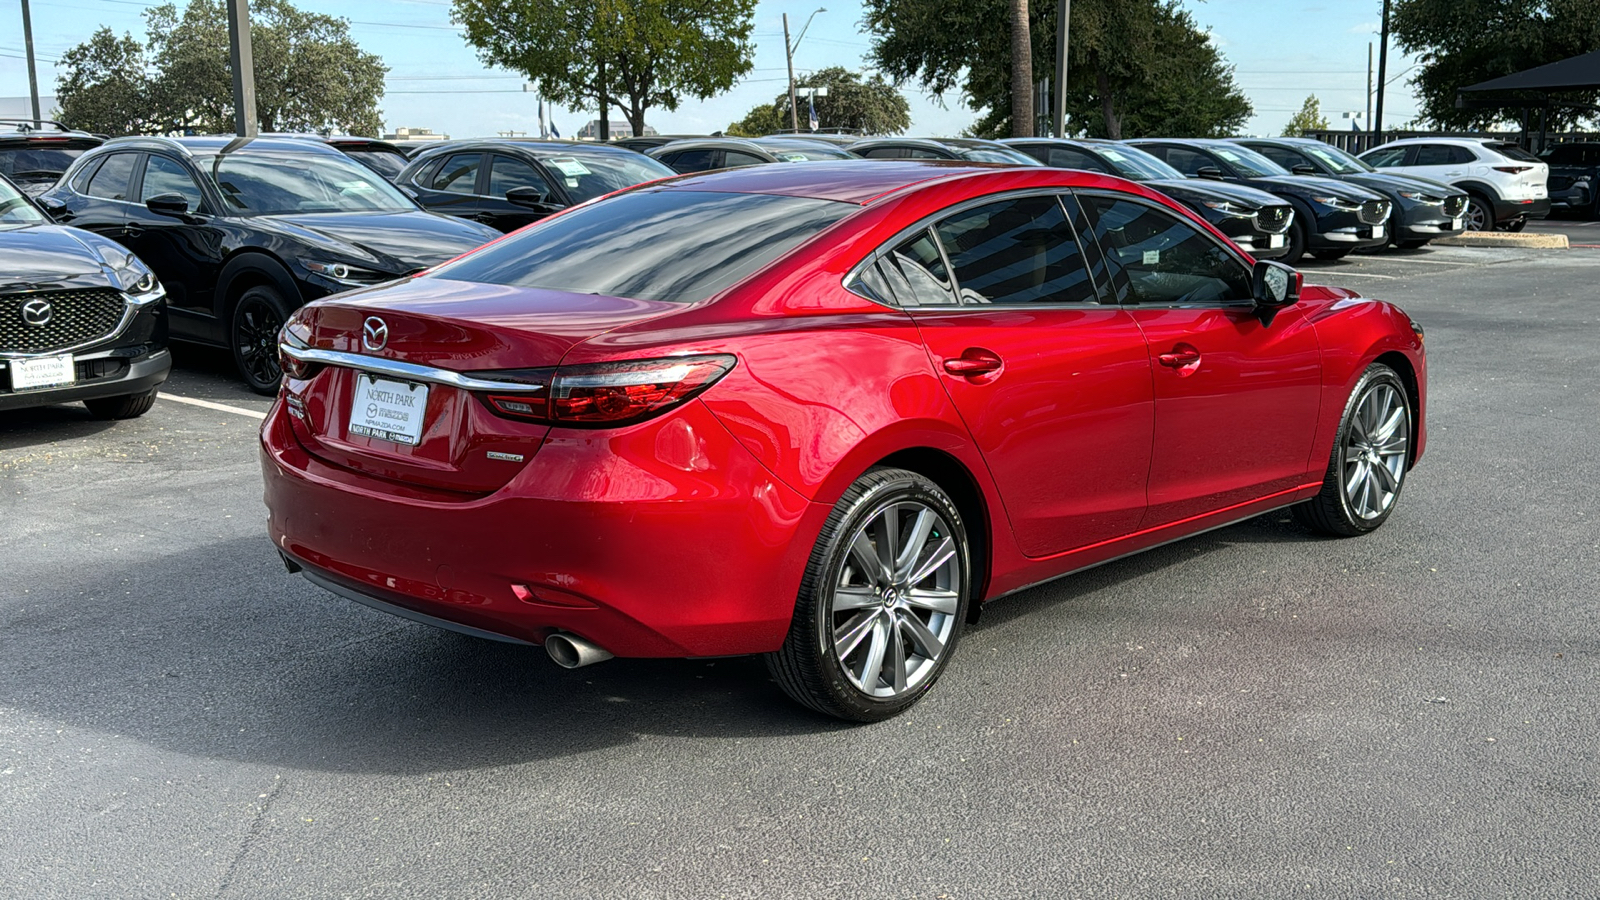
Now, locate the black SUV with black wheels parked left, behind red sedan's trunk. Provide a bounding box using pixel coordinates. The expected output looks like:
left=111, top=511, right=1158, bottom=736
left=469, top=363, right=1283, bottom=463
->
left=40, top=138, right=498, bottom=394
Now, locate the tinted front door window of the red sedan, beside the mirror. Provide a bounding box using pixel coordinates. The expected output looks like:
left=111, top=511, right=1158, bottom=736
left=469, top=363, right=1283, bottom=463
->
left=1080, top=195, right=1250, bottom=304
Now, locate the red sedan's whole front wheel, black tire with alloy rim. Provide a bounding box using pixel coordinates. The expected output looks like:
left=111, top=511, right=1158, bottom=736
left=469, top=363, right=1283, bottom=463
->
left=1293, top=362, right=1413, bottom=536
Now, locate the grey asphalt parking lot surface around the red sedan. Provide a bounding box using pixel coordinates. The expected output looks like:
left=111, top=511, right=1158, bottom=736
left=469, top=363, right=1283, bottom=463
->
left=0, top=221, right=1600, bottom=900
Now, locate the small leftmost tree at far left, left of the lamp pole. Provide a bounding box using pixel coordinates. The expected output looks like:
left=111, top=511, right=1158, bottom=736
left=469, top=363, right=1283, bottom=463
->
left=54, top=27, right=152, bottom=138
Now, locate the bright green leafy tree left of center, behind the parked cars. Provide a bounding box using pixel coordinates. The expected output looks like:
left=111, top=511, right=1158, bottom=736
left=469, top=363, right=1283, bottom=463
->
left=451, top=0, right=755, bottom=139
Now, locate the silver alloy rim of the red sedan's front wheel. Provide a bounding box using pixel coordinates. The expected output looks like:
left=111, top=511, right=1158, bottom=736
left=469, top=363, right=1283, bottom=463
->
left=1342, top=381, right=1411, bottom=520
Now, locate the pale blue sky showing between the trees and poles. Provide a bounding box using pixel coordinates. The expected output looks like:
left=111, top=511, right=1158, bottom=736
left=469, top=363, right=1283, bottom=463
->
left=0, top=0, right=1416, bottom=138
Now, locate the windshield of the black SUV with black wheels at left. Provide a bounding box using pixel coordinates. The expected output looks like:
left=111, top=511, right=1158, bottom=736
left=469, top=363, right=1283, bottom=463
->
left=195, top=151, right=418, bottom=216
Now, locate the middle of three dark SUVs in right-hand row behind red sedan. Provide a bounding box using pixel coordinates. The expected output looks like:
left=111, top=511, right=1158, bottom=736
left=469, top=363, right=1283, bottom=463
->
left=1128, top=138, right=1390, bottom=266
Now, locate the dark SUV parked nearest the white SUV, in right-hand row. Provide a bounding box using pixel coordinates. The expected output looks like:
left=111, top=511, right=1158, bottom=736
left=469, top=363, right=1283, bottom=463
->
left=1234, top=138, right=1467, bottom=250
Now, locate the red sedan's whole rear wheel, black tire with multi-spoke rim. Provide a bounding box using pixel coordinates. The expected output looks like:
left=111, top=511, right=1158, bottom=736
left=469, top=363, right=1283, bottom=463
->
left=766, top=468, right=973, bottom=722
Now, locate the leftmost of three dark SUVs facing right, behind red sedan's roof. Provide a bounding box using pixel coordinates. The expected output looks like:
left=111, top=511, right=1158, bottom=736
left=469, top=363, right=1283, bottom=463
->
left=1002, top=138, right=1294, bottom=259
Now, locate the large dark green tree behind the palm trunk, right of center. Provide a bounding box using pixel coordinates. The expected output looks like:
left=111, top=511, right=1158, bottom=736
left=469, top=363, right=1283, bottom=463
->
left=864, top=0, right=1251, bottom=138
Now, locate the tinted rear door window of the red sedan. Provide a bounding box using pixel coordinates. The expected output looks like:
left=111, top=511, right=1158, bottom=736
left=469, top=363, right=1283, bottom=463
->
left=934, top=197, right=1096, bottom=304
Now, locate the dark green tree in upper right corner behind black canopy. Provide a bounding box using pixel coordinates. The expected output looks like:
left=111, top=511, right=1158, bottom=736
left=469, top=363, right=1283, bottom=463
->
left=1389, top=0, right=1600, bottom=128
